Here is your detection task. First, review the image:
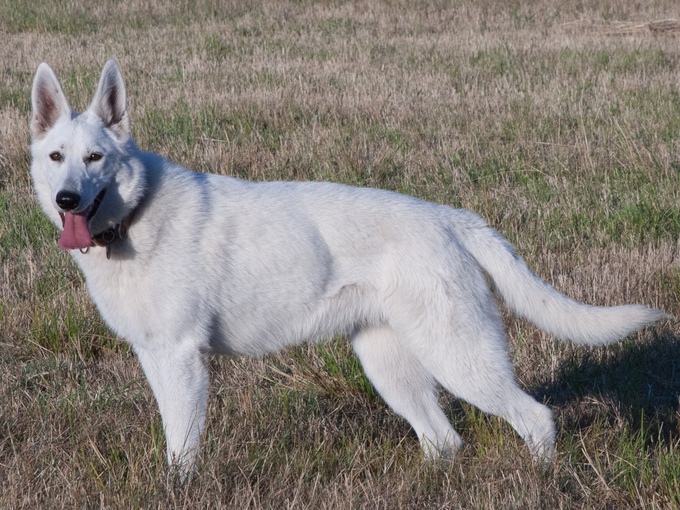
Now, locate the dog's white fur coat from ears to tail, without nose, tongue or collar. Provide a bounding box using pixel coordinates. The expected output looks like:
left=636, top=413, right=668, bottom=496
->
left=31, top=60, right=665, bottom=473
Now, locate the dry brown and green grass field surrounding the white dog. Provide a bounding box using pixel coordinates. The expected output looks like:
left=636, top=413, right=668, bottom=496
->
left=0, top=0, right=680, bottom=509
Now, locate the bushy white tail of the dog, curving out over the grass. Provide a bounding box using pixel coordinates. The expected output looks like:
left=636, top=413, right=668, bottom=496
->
left=460, top=209, right=670, bottom=345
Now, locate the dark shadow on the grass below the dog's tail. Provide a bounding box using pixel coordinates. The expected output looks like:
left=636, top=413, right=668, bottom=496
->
left=531, top=329, right=680, bottom=441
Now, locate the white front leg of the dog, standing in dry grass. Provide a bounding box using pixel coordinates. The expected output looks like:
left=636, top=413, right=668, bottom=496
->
left=135, top=342, right=209, bottom=480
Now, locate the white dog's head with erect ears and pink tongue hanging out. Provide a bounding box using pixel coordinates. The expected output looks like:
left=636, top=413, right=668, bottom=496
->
left=31, top=60, right=145, bottom=250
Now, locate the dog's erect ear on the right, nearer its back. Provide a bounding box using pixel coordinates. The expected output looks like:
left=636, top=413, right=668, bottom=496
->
left=90, top=59, right=130, bottom=138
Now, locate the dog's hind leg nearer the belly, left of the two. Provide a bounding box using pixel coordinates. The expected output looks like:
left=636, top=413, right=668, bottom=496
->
left=352, top=326, right=463, bottom=459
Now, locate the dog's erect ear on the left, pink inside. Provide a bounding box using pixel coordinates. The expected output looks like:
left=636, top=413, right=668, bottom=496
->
left=31, top=62, right=71, bottom=140
